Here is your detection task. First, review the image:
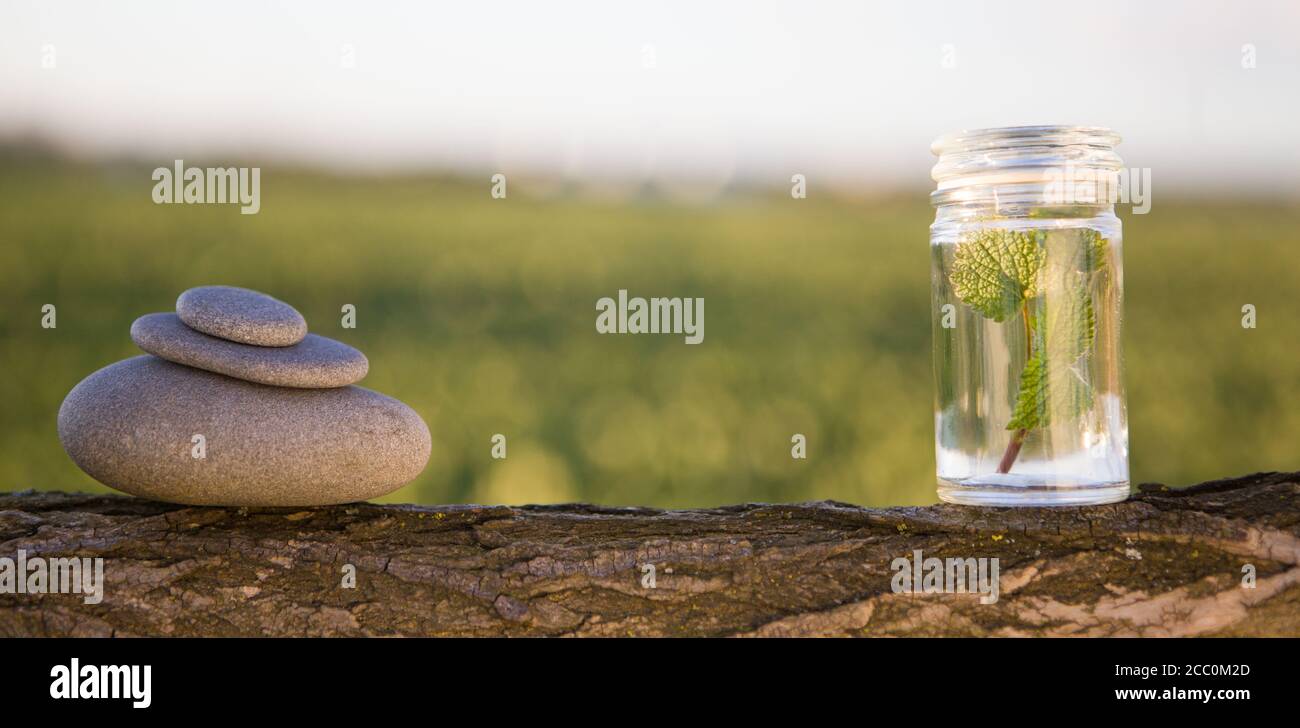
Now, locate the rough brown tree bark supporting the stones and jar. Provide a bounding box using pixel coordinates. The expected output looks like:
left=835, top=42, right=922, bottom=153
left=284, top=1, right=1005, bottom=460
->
left=0, top=473, right=1300, bottom=636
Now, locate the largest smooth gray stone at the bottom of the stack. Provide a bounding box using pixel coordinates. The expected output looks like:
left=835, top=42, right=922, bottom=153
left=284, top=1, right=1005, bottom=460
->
left=59, top=356, right=430, bottom=506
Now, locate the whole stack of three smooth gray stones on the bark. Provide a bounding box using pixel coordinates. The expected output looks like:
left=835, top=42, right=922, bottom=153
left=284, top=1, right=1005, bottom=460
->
left=59, top=286, right=430, bottom=506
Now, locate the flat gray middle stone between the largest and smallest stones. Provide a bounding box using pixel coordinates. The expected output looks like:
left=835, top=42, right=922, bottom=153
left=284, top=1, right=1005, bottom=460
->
left=131, top=313, right=371, bottom=389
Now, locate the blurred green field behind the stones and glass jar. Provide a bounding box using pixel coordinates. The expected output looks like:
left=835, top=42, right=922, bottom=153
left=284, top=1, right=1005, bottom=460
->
left=0, top=159, right=1300, bottom=507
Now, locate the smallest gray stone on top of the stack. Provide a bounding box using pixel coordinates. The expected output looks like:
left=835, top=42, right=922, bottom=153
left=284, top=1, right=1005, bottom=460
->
left=176, top=286, right=307, bottom=346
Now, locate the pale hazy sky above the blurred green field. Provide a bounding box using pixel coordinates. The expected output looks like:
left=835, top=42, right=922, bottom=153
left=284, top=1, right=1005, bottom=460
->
left=0, top=0, right=1300, bottom=196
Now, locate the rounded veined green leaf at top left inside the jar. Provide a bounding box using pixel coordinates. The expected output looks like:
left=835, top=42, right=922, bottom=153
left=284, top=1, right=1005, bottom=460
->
left=948, top=228, right=1047, bottom=321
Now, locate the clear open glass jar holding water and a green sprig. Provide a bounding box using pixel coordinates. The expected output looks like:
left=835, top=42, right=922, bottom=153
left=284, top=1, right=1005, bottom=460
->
left=930, top=126, right=1128, bottom=506
